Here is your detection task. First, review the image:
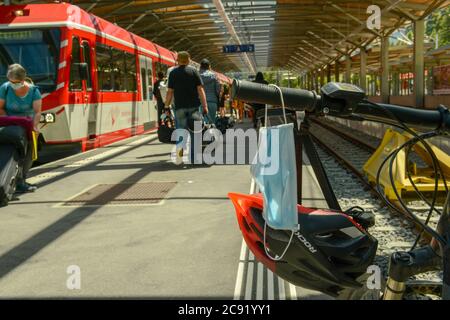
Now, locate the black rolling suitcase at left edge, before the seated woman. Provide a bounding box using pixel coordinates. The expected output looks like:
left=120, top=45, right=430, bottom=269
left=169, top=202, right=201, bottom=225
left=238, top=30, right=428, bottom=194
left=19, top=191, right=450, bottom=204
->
left=0, top=144, right=19, bottom=206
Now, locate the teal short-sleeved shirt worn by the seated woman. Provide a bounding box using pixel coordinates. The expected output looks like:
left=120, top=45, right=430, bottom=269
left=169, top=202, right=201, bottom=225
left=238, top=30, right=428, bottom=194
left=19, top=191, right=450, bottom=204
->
left=0, top=81, right=42, bottom=117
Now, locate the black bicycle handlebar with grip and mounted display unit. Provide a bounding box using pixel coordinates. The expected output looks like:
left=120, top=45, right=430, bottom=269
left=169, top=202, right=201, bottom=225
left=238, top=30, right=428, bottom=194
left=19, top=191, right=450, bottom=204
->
left=231, top=80, right=450, bottom=133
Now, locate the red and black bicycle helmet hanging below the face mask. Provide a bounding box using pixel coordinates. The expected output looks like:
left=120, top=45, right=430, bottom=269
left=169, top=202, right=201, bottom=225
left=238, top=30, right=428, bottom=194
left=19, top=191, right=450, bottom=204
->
left=228, top=193, right=378, bottom=296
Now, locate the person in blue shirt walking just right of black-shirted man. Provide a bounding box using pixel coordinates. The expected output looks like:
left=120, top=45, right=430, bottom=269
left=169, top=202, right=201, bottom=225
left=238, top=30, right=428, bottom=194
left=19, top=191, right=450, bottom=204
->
left=200, top=59, right=221, bottom=124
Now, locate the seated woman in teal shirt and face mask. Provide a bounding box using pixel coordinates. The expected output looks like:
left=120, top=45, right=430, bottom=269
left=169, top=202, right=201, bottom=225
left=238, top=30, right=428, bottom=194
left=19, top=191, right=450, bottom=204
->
left=0, top=64, right=42, bottom=193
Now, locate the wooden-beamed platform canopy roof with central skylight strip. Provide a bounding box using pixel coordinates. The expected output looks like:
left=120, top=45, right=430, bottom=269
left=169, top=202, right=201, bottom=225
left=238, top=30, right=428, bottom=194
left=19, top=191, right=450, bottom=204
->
left=0, top=0, right=449, bottom=72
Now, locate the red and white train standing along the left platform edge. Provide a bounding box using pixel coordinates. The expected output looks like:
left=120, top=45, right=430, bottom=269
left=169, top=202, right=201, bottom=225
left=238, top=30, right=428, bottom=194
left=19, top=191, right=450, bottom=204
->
left=0, top=3, right=229, bottom=151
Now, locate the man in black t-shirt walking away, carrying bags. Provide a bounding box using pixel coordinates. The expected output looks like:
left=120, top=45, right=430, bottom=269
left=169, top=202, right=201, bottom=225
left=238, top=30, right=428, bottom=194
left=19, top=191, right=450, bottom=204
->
left=166, top=51, right=208, bottom=164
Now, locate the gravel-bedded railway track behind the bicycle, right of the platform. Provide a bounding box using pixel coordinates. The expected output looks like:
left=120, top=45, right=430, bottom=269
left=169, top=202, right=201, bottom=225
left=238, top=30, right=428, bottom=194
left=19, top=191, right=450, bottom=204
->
left=310, top=120, right=442, bottom=296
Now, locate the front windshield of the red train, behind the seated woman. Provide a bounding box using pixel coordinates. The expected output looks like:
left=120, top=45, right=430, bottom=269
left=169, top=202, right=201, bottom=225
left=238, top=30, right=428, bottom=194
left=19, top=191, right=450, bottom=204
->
left=0, top=29, right=61, bottom=92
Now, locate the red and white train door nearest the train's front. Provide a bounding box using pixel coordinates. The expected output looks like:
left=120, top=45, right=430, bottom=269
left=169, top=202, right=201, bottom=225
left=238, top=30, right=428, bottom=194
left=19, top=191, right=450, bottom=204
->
left=69, top=36, right=97, bottom=139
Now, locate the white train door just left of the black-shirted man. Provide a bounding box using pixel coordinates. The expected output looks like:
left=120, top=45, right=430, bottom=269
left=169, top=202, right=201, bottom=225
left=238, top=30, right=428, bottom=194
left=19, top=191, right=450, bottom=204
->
left=139, top=56, right=158, bottom=130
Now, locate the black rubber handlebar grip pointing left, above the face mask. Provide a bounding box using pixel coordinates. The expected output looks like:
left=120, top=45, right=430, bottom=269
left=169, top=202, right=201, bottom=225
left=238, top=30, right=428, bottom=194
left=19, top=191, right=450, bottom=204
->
left=231, top=79, right=321, bottom=111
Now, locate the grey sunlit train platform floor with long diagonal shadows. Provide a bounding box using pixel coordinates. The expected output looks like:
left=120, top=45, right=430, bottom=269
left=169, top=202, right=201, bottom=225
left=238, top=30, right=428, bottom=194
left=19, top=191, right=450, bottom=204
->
left=0, top=123, right=328, bottom=300
